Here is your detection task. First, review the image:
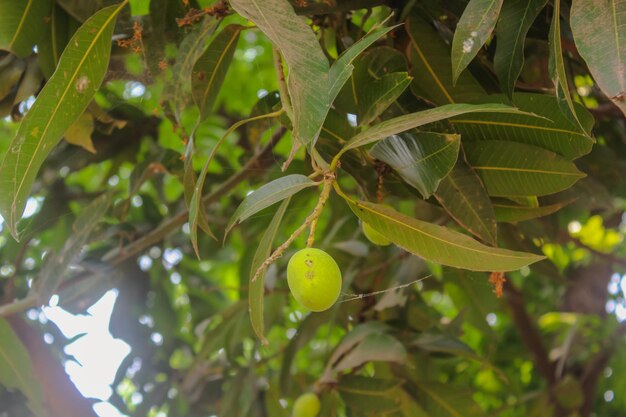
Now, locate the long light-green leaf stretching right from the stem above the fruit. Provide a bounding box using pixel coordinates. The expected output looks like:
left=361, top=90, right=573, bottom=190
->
left=347, top=200, right=543, bottom=271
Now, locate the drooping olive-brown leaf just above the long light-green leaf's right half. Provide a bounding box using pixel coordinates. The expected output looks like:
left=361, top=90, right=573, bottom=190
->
left=435, top=158, right=497, bottom=246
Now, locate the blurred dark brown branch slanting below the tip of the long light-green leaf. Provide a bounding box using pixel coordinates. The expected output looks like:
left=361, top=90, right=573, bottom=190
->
left=505, top=281, right=557, bottom=387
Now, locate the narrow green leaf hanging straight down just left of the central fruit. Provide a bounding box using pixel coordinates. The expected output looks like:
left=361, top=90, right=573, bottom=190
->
left=248, top=197, right=291, bottom=345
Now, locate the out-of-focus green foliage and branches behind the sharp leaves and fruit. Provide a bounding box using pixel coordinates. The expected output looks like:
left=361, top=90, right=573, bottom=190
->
left=0, top=0, right=626, bottom=417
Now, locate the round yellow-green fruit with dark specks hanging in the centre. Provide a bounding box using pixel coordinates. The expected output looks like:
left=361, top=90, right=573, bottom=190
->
left=287, top=248, right=341, bottom=311
